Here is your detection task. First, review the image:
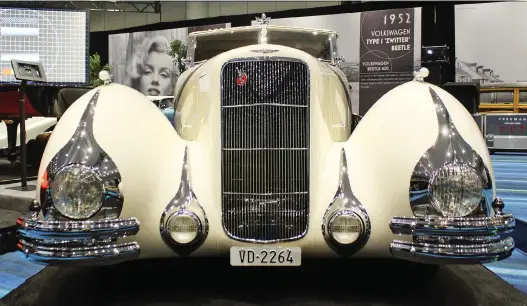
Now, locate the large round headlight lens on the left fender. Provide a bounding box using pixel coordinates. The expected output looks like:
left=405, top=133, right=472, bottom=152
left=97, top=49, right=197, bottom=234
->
left=50, top=164, right=104, bottom=219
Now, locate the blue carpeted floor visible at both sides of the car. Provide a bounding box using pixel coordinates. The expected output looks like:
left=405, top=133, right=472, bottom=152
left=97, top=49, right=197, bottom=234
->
left=0, top=154, right=527, bottom=305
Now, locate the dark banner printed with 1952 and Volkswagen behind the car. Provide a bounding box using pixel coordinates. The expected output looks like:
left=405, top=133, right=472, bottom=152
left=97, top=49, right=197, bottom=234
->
left=359, top=8, right=415, bottom=115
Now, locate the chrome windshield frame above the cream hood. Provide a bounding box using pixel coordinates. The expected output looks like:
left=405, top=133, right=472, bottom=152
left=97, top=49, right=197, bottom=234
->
left=187, top=25, right=338, bottom=67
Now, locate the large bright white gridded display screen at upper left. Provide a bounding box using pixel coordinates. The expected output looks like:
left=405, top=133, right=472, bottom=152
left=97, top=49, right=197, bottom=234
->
left=0, top=7, right=89, bottom=85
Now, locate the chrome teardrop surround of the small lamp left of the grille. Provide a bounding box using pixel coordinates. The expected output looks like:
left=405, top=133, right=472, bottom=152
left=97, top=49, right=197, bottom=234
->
left=159, top=147, right=209, bottom=256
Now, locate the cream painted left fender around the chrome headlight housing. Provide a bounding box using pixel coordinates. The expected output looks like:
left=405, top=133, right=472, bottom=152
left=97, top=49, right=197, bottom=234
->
left=37, top=83, right=189, bottom=257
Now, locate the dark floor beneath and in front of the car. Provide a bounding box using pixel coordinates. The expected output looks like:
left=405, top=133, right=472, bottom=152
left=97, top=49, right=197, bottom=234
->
left=0, top=259, right=527, bottom=306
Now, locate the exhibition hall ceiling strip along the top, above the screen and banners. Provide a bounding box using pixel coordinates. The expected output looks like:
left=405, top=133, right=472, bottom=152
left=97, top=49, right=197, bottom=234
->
left=0, top=0, right=341, bottom=32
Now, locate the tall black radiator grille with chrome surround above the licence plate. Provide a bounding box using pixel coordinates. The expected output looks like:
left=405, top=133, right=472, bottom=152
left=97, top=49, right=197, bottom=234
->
left=221, top=58, right=310, bottom=243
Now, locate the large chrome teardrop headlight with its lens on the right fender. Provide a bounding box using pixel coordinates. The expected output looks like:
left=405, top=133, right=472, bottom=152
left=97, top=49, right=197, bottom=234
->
left=409, top=88, right=493, bottom=217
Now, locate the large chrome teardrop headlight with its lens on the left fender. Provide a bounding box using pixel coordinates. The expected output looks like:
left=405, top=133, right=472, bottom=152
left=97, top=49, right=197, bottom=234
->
left=39, top=91, right=124, bottom=220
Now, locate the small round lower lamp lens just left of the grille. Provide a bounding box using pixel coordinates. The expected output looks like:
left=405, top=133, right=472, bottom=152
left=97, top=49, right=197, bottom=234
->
left=167, top=212, right=201, bottom=244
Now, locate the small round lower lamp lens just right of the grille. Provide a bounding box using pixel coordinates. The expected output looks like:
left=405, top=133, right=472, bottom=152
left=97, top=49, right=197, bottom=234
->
left=329, top=212, right=364, bottom=244
